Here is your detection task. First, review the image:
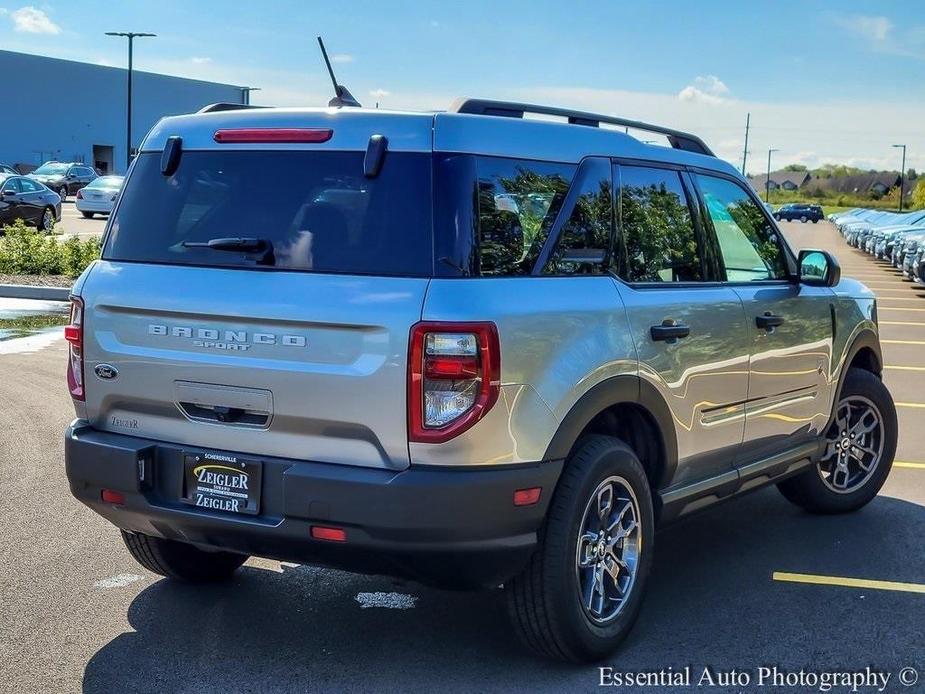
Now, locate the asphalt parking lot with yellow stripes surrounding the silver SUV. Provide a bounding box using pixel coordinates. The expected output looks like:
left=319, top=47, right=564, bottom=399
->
left=0, top=222, right=925, bottom=692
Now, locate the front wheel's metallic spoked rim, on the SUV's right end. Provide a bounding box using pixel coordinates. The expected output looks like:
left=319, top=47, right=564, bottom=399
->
left=817, top=395, right=884, bottom=494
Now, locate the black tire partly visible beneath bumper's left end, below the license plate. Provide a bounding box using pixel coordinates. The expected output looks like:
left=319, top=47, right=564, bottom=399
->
left=121, top=530, right=247, bottom=583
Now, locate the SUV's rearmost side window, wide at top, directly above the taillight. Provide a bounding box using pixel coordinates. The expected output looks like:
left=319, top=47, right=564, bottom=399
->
left=477, top=157, right=575, bottom=276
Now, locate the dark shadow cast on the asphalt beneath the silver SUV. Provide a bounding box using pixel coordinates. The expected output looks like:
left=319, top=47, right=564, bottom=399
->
left=83, top=489, right=925, bottom=692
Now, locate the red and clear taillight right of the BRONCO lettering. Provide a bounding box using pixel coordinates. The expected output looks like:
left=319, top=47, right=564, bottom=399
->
left=408, top=323, right=501, bottom=443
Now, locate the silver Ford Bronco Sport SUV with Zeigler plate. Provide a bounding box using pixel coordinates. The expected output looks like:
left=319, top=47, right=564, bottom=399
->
left=65, top=100, right=896, bottom=661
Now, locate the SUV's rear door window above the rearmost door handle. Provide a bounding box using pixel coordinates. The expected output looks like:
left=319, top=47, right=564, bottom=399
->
left=614, top=165, right=703, bottom=282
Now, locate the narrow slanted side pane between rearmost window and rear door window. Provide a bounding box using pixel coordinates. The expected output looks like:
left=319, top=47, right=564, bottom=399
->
left=544, top=159, right=613, bottom=275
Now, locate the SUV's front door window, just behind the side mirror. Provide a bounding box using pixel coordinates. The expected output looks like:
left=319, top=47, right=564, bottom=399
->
left=697, top=174, right=787, bottom=282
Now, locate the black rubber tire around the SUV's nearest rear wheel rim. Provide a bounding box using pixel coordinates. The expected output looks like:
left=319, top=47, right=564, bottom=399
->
left=505, top=435, right=655, bottom=662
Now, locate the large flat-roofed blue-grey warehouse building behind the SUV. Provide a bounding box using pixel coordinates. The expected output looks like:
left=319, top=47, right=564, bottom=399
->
left=0, top=51, right=245, bottom=173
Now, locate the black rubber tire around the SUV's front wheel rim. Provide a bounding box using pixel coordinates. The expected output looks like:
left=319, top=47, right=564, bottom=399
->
left=777, top=368, right=897, bottom=514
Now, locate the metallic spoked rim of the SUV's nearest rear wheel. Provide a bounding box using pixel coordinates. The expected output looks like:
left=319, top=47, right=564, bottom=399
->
left=575, top=476, right=642, bottom=625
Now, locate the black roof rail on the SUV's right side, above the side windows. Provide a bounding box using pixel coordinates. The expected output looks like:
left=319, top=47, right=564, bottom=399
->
left=449, top=98, right=716, bottom=157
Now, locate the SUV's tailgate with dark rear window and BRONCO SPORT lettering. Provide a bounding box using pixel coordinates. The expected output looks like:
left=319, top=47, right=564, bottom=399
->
left=81, top=109, right=433, bottom=469
